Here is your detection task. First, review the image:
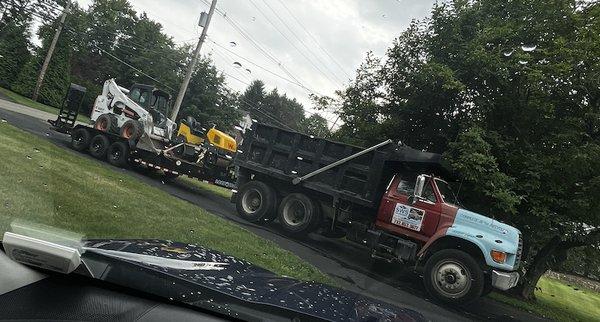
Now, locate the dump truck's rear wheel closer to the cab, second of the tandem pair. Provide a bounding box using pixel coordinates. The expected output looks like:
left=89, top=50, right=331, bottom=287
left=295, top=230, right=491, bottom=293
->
left=278, top=193, right=321, bottom=235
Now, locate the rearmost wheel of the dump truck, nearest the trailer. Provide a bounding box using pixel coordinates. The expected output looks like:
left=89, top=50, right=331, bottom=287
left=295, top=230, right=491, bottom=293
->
left=235, top=181, right=277, bottom=222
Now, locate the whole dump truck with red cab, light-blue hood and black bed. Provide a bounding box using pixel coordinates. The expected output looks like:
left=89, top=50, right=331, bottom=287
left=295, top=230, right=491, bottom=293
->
left=231, top=123, right=522, bottom=303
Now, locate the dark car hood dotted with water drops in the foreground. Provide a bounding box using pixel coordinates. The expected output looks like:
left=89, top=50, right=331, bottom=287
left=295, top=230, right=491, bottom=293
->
left=82, top=240, right=425, bottom=321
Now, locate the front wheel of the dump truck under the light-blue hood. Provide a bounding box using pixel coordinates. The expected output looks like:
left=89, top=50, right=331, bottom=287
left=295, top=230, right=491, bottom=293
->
left=423, top=249, right=484, bottom=304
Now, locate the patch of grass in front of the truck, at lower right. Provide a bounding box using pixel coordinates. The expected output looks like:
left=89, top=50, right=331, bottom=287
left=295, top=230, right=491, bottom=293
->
left=489, top=277, right=600, bottom=321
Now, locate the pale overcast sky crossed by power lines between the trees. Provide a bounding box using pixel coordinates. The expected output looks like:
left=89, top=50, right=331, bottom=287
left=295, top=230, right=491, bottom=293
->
left=71, top=0, right=435, bottom=121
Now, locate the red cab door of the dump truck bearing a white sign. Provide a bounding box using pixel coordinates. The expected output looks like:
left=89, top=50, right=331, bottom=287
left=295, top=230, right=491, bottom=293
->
left=375, top=175, right=441, bottom=241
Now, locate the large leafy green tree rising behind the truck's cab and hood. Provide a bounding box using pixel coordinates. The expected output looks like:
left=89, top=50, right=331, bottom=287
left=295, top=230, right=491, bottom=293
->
left=332, top=0, right=600, bottom=299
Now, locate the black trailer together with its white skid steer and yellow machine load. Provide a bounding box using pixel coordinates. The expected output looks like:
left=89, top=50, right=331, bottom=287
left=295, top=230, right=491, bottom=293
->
left=48, top=79, right=237, bottom=188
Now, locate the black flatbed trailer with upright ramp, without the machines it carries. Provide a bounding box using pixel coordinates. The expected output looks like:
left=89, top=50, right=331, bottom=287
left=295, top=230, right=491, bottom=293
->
left=48, top=84, right=235, bottom=188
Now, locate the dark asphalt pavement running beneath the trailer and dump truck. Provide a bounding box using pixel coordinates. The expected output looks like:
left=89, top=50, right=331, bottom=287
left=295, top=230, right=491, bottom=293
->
left=0, top=98, right=543, bottom=321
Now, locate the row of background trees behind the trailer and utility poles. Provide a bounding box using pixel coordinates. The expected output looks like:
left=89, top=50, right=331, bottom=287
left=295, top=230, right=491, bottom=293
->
left=0, top=0, right=327, bottom=134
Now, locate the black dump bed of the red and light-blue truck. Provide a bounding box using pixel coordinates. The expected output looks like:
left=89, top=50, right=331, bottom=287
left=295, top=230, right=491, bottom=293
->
left=235, top=123, right=445, bottom=208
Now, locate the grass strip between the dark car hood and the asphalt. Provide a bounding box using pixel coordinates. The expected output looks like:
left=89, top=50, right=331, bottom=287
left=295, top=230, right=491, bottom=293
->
left=0, top=122, right=330, bottom=283
